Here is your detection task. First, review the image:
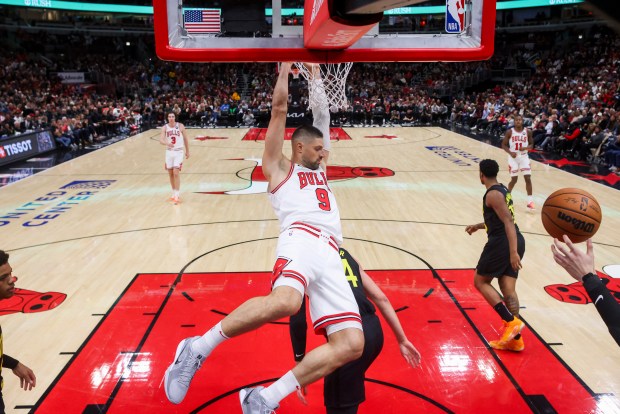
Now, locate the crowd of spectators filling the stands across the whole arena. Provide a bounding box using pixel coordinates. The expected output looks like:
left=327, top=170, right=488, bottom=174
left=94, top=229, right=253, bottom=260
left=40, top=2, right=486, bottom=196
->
left=0, top=23, right=620, bottom=175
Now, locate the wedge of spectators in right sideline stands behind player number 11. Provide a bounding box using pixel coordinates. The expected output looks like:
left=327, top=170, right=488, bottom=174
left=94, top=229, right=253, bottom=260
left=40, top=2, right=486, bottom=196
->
left=450, top=28, right=620, bottom=171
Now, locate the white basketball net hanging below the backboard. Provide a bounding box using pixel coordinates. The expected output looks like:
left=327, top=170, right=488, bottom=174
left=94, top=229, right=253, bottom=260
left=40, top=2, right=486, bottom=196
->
left=295, top=62, right=353, bottom=112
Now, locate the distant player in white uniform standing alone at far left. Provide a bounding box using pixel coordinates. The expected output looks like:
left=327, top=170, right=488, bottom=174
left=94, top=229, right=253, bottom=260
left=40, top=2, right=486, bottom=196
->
left=159, top=112, right=189, bottom=204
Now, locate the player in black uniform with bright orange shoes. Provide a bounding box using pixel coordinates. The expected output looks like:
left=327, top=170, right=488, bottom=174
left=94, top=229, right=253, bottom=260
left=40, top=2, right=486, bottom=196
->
left=465, top=160, right=525, bottom=351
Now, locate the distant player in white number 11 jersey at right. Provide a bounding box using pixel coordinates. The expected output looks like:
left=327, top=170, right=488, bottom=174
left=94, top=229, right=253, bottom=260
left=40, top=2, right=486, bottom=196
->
left=502, top=115, right=534, bottom=210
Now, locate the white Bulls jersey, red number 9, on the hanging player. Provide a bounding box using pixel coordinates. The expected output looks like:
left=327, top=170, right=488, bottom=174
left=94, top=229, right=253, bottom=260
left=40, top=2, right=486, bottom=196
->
left=269, top=163, right=342, bottom=245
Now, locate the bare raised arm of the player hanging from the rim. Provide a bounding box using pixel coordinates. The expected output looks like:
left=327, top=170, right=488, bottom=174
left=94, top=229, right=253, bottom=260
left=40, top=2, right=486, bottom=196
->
left=263, top=62, right=291, bottom=185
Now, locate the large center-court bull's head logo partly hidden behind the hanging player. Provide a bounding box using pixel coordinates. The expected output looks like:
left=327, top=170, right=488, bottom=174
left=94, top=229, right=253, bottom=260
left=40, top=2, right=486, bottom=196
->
left=198, top=158, right=394, bottom=195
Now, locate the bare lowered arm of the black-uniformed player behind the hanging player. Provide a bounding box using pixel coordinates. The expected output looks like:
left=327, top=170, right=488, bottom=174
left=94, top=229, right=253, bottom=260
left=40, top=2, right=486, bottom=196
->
left=358, top=263, right=422, bottom=368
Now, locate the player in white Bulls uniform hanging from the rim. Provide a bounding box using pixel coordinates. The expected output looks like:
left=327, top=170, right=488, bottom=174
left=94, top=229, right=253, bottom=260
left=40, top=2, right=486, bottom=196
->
left=164, top=63, right=364, bottom=414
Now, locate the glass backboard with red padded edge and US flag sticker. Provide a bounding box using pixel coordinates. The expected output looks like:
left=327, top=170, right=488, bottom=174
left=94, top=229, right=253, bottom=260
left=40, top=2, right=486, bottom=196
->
left=153, top=0, right=496, bottom=63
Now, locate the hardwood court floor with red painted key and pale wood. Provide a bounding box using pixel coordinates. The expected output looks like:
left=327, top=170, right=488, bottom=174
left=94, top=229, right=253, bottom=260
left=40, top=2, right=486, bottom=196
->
left=0, top=127, right=620, bottom=413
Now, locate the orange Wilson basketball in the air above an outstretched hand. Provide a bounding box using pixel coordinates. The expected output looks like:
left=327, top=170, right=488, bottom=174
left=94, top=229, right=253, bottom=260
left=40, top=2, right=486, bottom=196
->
left=541, top=188, right=603, bottom=243
